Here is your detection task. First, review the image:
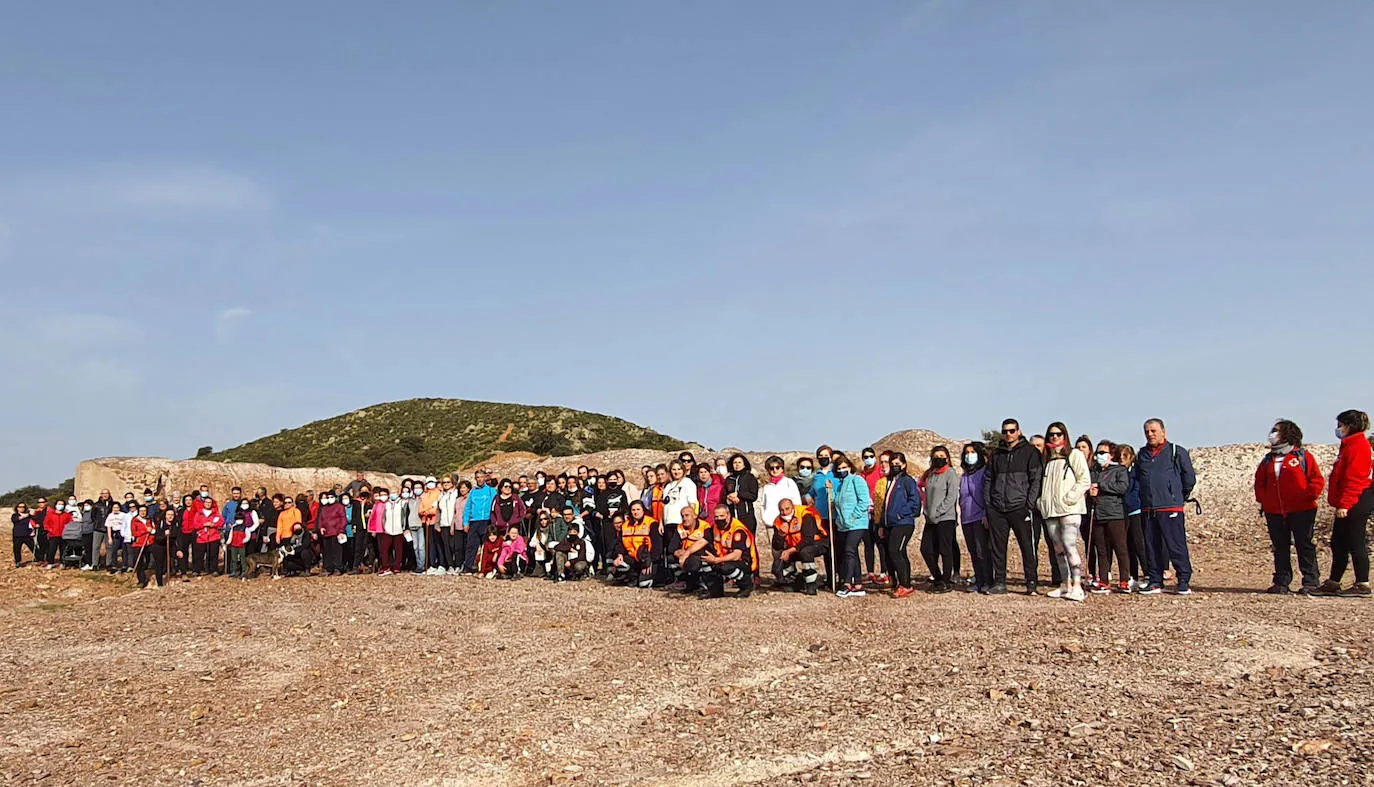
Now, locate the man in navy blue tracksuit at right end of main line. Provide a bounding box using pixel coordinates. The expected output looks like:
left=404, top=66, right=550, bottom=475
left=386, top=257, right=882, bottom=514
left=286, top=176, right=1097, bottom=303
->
left=1131, top=418, right=1198, bottom=596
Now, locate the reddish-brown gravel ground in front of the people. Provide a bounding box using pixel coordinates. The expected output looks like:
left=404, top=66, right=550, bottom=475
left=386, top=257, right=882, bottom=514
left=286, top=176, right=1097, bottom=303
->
left=0, top=538, right=1374, bottom=786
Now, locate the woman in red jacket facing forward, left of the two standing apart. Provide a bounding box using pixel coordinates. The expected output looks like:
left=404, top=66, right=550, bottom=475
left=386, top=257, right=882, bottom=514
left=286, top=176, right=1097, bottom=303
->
left=1254, top=420, right=1326, bottom=595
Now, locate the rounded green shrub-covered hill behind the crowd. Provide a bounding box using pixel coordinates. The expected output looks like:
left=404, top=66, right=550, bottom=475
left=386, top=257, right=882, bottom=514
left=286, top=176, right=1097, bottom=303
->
left=201, top=398, right=684, bottom=475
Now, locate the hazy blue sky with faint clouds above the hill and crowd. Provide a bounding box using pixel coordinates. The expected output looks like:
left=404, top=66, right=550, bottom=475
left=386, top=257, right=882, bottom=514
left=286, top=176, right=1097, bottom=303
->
left=0, top=0, right=1374, bottom=489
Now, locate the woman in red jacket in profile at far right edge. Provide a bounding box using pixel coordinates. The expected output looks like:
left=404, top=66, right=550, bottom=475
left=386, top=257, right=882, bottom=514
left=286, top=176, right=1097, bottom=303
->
left=1318, top=409, right=1374, bottom=599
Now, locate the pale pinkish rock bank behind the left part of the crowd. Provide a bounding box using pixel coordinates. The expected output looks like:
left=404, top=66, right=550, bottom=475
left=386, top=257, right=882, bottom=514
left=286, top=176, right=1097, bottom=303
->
left=76, top=456, right=400, bottom=500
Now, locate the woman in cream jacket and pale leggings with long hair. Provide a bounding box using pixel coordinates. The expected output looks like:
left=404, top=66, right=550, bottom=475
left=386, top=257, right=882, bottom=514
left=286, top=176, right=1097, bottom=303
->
left=1037, top=422, right=1092, bottom=602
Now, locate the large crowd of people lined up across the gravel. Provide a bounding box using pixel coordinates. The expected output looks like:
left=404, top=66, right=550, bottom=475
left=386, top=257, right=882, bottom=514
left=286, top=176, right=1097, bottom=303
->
left=12, top=411, right=1374, bottom=602
